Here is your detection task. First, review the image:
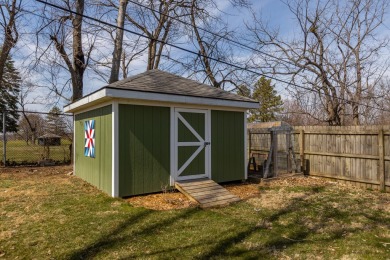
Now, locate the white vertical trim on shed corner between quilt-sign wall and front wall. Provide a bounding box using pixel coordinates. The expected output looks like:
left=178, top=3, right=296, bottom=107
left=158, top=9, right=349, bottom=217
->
left=111, top=102, right=119, bottom=197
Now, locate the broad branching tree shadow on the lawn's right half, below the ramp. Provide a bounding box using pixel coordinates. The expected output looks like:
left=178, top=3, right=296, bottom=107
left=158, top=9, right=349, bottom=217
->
left=198, top=188, right=370, bottom=259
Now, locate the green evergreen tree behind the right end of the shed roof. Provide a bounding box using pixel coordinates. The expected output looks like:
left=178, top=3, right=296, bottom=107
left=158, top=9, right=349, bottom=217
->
left=239, top=77, right=283, bottom=122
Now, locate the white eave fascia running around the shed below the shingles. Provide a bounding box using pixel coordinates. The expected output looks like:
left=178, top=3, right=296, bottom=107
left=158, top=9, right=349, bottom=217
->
left=64, top=88, right=259, bottom=112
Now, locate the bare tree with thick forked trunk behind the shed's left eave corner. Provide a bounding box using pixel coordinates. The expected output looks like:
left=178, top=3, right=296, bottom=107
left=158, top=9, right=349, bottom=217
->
left=30, top=0, right=99, bottom=102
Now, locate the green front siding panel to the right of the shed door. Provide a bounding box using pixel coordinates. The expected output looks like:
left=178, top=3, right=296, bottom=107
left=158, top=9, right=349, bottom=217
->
left=211, top=110, right=245, bottom=182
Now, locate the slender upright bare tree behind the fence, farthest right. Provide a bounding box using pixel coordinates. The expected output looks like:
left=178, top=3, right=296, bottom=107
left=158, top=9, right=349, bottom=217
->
left=331, top=0, right=389, bottom=125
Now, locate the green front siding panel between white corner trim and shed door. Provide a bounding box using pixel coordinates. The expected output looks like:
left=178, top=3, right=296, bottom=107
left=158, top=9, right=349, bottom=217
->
left=119, top=104, right=170, bottom=197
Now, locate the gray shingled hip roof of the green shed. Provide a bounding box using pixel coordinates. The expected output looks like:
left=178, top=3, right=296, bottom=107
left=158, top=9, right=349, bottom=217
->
left=105, top=70, right=257, bottom=103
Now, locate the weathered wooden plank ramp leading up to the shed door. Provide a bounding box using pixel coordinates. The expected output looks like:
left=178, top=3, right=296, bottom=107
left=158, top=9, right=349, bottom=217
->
left=175, top=178, right=240, bottom=208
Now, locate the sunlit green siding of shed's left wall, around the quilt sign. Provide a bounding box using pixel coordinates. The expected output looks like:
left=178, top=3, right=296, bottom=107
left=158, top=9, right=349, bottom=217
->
left=75, top=105, right=112, bottom=195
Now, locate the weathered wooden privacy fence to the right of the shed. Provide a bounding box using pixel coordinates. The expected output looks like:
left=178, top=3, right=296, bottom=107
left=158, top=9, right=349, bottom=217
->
left=248, top=126, right=390, bottom=191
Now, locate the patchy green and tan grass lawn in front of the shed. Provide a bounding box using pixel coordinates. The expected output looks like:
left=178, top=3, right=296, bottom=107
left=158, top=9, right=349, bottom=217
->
left=0, top=167, right=390, bottom=259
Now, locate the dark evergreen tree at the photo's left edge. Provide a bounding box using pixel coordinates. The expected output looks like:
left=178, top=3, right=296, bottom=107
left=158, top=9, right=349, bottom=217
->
left=0, top=56, right=22, bottom=132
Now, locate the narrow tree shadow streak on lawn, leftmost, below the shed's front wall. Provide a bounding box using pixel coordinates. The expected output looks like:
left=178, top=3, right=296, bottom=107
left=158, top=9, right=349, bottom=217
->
left=67, top=208, right=197, bottom=260
